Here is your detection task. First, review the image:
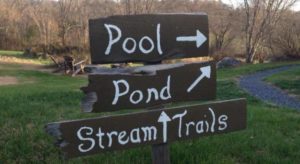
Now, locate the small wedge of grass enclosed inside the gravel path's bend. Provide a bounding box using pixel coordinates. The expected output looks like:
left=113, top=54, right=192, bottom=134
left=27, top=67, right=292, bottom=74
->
left=266, top=67, right=300, bottom=98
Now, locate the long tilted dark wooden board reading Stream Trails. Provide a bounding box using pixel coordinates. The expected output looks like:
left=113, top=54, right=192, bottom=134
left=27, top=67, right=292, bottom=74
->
left=46, top=99, right=246, bottom=158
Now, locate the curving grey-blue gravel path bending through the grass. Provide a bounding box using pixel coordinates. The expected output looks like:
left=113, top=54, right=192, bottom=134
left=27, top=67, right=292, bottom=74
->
left=239, top=65, right=300, bottom=110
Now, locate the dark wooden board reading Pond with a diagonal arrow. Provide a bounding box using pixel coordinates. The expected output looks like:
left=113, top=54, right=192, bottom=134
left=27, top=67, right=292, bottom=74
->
left=82, top=62, right=216, bottom=112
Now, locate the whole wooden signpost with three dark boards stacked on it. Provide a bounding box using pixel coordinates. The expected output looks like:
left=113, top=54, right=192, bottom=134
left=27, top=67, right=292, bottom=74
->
left=46, top=13, right=247, bottom=164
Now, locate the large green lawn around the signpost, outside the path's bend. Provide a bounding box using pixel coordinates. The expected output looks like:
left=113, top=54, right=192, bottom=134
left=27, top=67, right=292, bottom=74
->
left=0, top=62, right=300, bottom=164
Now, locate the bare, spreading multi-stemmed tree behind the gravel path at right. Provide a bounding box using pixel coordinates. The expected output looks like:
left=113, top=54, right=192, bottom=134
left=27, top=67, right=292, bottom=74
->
left=244, top=0, right=297, bottom=63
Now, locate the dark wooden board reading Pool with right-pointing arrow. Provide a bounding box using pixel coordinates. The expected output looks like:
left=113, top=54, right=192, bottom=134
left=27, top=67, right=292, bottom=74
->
left=89, top=14, right=209, bottom=64
